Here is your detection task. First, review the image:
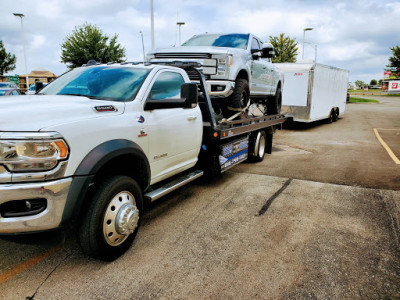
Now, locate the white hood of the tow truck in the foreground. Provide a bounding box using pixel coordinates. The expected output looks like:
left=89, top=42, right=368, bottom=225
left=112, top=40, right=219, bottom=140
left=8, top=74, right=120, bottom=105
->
left=0, top=95, right=125, bottom=132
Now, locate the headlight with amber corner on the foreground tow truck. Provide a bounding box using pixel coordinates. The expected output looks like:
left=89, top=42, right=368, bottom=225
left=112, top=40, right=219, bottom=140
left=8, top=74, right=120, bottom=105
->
left=0, top=134, right=68, bottom=172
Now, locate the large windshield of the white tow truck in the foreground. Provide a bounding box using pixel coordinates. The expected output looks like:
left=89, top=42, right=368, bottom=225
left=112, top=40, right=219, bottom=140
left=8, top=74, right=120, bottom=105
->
left=39, top=66, right=150, bottom=101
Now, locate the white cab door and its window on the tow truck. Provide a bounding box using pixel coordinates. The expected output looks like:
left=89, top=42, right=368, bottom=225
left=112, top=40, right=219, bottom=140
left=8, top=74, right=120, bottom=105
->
left=144, top=70, right=203, bottom=184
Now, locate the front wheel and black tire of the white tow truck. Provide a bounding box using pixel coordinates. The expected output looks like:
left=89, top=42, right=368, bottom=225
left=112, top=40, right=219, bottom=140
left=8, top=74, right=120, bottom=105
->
left=79, top=176, right=143, bottom=261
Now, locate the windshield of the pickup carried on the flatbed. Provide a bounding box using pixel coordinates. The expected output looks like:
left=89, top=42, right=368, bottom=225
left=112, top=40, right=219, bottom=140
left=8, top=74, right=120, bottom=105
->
left=182, top=34, right=249, bottom=49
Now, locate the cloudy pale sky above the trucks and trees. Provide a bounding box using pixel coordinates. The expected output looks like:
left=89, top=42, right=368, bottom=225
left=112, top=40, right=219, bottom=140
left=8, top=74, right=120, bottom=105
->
left=0, top=0, right=400, bottom=83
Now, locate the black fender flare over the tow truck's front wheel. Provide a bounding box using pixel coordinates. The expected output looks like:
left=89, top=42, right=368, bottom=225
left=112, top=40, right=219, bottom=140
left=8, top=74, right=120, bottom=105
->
left=61, top=139, right=151, bottom=226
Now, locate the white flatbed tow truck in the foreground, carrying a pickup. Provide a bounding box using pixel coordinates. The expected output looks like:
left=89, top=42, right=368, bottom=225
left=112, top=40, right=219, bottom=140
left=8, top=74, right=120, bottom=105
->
left=0, top=62, right=285, bottom=260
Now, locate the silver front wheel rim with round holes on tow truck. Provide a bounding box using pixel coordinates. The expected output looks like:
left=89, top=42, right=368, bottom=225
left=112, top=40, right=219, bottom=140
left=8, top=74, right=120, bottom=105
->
left=103, top=191, right=139, bottom=246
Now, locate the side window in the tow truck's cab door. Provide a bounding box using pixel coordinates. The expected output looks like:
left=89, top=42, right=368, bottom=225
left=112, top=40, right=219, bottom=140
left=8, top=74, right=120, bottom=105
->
left=150, top=72, right=185, bottom=100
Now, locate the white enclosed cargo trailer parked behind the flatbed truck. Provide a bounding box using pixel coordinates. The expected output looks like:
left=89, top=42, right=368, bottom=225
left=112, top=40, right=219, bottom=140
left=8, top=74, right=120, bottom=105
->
left=275, top=62, right=349, bottom=123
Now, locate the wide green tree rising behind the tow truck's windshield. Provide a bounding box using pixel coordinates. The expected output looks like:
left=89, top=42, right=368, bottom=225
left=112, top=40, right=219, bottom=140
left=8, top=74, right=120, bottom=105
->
left=61, top=23, right=126, bottom=69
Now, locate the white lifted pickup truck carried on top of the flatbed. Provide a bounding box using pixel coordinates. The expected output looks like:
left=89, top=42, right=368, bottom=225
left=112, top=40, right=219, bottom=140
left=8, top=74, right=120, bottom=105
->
left=147, top=33, right=283, bottom=115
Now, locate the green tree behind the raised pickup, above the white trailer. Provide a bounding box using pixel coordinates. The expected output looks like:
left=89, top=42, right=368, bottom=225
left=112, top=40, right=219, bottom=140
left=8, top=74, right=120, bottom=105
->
left=269, top=33, right=299, bottom=63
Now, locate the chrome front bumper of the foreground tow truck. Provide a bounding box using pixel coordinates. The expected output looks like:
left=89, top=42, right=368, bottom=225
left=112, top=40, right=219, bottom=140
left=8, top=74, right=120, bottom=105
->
left=0, top=178, right=72, bottom=234
